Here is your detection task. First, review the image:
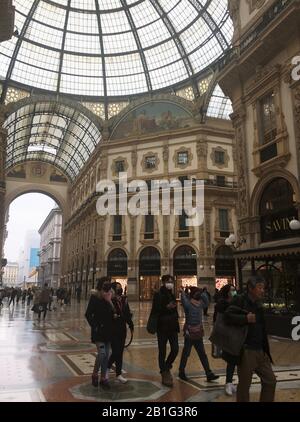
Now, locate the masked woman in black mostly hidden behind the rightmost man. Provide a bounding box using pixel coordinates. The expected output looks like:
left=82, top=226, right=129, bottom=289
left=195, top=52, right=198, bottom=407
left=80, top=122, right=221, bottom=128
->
left=213, top=284, right=236, bottom=396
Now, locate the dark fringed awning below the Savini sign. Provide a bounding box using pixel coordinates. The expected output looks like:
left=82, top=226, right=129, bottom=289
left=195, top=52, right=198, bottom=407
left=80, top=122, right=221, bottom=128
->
left=234, top=243, right=300, bottom=259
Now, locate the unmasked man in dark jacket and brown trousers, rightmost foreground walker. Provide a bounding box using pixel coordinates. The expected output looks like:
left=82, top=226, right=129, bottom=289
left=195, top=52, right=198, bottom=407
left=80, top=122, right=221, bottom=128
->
left=225, top=276, right=276, bottom=402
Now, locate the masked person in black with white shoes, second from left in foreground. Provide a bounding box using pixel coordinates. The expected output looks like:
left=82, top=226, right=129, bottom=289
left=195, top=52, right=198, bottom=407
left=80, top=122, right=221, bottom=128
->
left=108, top=282, right=134, bottom=384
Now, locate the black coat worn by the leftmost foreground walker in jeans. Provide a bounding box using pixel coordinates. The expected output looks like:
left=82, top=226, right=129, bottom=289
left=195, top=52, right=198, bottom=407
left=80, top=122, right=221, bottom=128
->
left=85, top=290, right=115, bottom=343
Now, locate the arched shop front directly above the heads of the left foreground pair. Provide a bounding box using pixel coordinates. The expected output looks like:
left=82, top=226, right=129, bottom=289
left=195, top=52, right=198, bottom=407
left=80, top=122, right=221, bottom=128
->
left=107, top=249, right=128, bottom=293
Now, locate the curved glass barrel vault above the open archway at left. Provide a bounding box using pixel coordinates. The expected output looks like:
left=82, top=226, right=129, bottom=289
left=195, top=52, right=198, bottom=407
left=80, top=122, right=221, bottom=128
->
left=4, top=102, right=101, bottom=180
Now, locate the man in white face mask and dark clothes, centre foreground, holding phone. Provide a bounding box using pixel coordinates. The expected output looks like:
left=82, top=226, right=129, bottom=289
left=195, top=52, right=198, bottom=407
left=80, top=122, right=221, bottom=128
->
left=152, top=275, right=180, bottom=387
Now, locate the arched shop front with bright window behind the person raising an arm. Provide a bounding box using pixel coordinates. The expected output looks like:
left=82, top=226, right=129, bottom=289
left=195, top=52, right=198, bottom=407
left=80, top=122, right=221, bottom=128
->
left=173, top=246, right=198, bottom=299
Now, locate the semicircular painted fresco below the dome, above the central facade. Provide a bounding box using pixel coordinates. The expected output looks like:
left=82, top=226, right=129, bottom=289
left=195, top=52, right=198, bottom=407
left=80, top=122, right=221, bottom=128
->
left=112, top=101, right=194, bottom=139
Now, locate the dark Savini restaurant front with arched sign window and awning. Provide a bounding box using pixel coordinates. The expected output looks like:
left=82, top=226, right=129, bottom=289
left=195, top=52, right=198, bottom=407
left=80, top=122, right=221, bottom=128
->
left=235, top=178, right=300, bottom=338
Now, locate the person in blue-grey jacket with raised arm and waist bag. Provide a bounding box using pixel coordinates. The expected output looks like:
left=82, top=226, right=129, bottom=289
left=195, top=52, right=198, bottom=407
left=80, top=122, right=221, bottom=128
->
left=179, top=287, right=219, bottom=382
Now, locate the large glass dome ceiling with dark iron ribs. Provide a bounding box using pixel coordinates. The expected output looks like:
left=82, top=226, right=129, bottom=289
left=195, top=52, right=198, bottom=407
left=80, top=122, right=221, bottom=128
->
left=0, top=0, right=233, bottom=98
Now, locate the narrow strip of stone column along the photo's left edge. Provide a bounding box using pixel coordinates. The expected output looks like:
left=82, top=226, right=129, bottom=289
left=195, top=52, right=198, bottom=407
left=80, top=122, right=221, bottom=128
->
left=0, top=105, right=7, bottom=274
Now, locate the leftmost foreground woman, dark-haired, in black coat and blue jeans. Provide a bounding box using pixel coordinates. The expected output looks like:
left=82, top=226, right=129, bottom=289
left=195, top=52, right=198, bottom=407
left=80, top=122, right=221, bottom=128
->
left=85, top=277, right=116, bottom=389
